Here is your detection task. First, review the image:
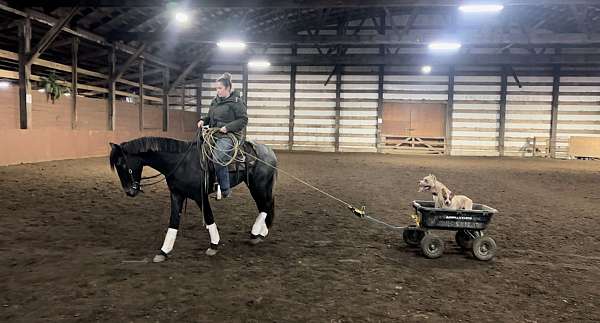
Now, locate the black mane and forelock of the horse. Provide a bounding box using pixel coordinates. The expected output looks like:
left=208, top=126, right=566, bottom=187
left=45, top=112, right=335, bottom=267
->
left=110, top=137, right=190, bottom=168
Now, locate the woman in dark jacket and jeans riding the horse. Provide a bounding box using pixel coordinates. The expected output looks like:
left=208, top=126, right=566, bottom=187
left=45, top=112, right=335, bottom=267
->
left=198, top=73, right=248, bottom=197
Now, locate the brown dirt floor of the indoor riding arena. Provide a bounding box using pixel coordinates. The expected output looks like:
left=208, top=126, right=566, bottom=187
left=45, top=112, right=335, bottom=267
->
left=0, top=152, right=600, bottom=322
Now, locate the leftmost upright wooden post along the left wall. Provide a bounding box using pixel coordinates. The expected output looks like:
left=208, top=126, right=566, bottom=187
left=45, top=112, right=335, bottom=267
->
left=19, top=19, right=33, bottom=129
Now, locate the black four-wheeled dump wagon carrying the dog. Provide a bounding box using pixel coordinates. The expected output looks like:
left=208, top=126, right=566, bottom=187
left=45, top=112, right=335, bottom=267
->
left=402, top=201, right=498, bottom=261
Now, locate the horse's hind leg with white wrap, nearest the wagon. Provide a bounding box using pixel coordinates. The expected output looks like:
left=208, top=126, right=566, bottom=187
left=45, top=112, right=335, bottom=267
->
left=248, top=169, right=275, bottom=244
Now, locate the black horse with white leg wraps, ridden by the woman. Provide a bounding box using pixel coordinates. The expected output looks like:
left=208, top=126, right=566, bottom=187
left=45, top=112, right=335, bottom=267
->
left=110, top=137, right=277, bottom=262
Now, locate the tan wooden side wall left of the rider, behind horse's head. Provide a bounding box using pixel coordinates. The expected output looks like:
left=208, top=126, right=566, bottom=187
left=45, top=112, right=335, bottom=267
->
left=0, top=86, right=196, bottom=165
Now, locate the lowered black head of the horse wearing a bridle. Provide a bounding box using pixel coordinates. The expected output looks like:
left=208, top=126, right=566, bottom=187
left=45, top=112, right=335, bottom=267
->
left=110, top=143, right=144, bottom=197
